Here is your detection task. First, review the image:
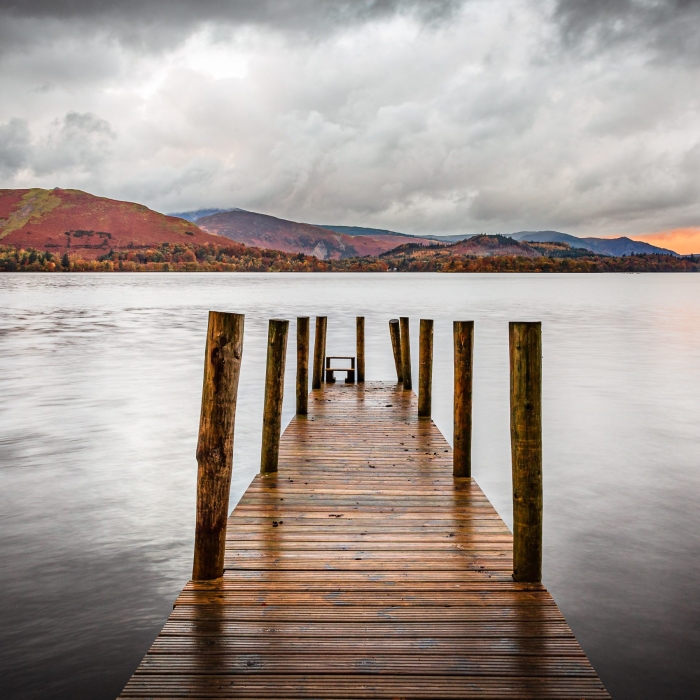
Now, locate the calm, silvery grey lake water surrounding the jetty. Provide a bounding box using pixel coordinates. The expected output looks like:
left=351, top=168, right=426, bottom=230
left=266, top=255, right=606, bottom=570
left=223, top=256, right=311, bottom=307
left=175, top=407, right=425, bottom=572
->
left=0, top=274, right=700, bottom=699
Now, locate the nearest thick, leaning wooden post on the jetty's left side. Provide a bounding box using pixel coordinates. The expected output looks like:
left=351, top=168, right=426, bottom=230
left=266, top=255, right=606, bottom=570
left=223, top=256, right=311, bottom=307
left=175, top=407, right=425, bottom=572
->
left=192, top=311, right=245, bottom=581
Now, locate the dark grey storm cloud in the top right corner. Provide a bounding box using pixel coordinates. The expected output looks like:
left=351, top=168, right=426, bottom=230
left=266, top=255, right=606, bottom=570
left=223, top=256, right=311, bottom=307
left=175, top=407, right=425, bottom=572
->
left=553, top=0, right=700, bottom=64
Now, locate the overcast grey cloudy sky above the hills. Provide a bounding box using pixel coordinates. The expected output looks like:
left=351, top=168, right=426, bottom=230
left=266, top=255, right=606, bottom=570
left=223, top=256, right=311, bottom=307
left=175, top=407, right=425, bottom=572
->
left=0, top=0, right=700, bottom=252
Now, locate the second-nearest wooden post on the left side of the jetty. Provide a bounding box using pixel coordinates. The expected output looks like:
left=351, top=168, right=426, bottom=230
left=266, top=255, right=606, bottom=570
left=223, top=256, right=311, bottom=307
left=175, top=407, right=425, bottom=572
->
left=260, top=318, right=289, bottom=474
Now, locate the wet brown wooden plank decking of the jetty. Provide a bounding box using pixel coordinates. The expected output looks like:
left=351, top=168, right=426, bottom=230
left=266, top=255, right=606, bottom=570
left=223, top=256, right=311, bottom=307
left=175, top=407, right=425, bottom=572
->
left=122, top=382, right=609, bottom=699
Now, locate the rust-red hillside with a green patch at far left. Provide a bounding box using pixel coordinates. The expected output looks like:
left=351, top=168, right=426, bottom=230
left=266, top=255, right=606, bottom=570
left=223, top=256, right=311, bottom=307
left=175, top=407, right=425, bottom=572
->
left=0, top=188, right=221, bottom=259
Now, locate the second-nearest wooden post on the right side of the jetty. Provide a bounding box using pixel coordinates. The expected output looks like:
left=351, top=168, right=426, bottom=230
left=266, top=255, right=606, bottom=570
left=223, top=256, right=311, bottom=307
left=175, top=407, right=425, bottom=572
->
left=452, top=321, right=474, bottom=477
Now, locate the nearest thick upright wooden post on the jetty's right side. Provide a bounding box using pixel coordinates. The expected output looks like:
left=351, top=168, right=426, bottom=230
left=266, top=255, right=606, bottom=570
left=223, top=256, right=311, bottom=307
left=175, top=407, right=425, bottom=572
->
left=509, top=322, right=542, bottom=583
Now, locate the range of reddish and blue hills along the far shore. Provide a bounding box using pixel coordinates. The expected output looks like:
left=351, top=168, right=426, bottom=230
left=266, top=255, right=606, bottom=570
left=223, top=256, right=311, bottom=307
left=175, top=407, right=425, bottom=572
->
left=0, top=188, right=676, bottom=260
